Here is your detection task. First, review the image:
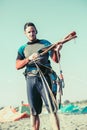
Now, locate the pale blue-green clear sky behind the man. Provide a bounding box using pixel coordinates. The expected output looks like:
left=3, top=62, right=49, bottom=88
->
left=0, top=0, right=87, bottom=106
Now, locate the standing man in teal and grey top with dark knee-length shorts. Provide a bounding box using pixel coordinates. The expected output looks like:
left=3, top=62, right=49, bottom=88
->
left=16, top=22, right=62, bottom=130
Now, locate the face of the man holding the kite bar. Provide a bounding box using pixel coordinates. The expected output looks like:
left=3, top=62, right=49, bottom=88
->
left=25, top=26, right=36, bottom=41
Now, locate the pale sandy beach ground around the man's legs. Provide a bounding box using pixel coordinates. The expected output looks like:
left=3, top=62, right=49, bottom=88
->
left=0, top=109, right=87, bottom=130
